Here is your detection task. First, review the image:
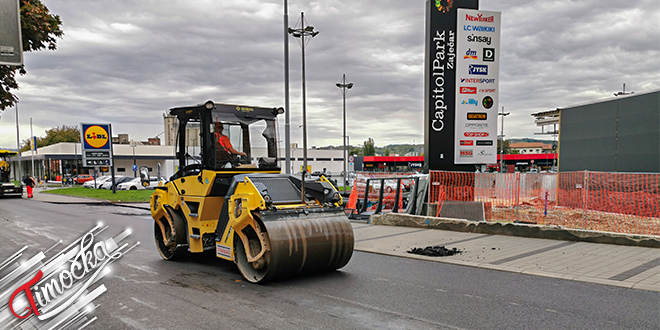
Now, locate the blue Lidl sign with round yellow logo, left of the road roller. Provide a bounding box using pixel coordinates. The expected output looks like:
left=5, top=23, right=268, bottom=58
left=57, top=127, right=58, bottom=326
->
left=80, top=123, right=112, bottom=167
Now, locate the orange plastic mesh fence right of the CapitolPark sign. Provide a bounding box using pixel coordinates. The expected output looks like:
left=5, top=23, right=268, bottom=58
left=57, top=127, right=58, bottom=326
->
left=428, top=171, right=660, bottom=235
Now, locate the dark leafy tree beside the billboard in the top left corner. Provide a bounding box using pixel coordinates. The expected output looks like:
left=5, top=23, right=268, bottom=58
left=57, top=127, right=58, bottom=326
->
left=0, top=0, right=64, bottom=111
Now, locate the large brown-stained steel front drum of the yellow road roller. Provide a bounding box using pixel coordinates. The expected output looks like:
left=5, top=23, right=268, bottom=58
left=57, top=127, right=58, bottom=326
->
left=234, top=209, right=354, bottom=283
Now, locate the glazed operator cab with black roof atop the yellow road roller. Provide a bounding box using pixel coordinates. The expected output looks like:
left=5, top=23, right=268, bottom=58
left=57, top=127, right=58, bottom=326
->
left=170, top=101, right=284, bottom=174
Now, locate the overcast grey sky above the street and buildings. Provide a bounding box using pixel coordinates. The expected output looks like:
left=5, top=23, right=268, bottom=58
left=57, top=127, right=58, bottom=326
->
left=0, top=0, right=660, bottom=148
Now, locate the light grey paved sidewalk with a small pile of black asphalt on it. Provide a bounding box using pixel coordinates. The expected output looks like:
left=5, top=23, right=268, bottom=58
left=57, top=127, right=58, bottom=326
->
left=353, top=222, right=660, bottom=292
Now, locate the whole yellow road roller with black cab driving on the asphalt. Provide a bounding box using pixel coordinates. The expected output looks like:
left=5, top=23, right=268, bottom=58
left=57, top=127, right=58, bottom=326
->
left=150, top=101, right=354, bottom=283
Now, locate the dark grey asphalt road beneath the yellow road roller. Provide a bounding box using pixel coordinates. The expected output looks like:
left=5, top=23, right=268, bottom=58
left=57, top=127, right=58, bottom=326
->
left=0, top=199, right=660, bottom=329
